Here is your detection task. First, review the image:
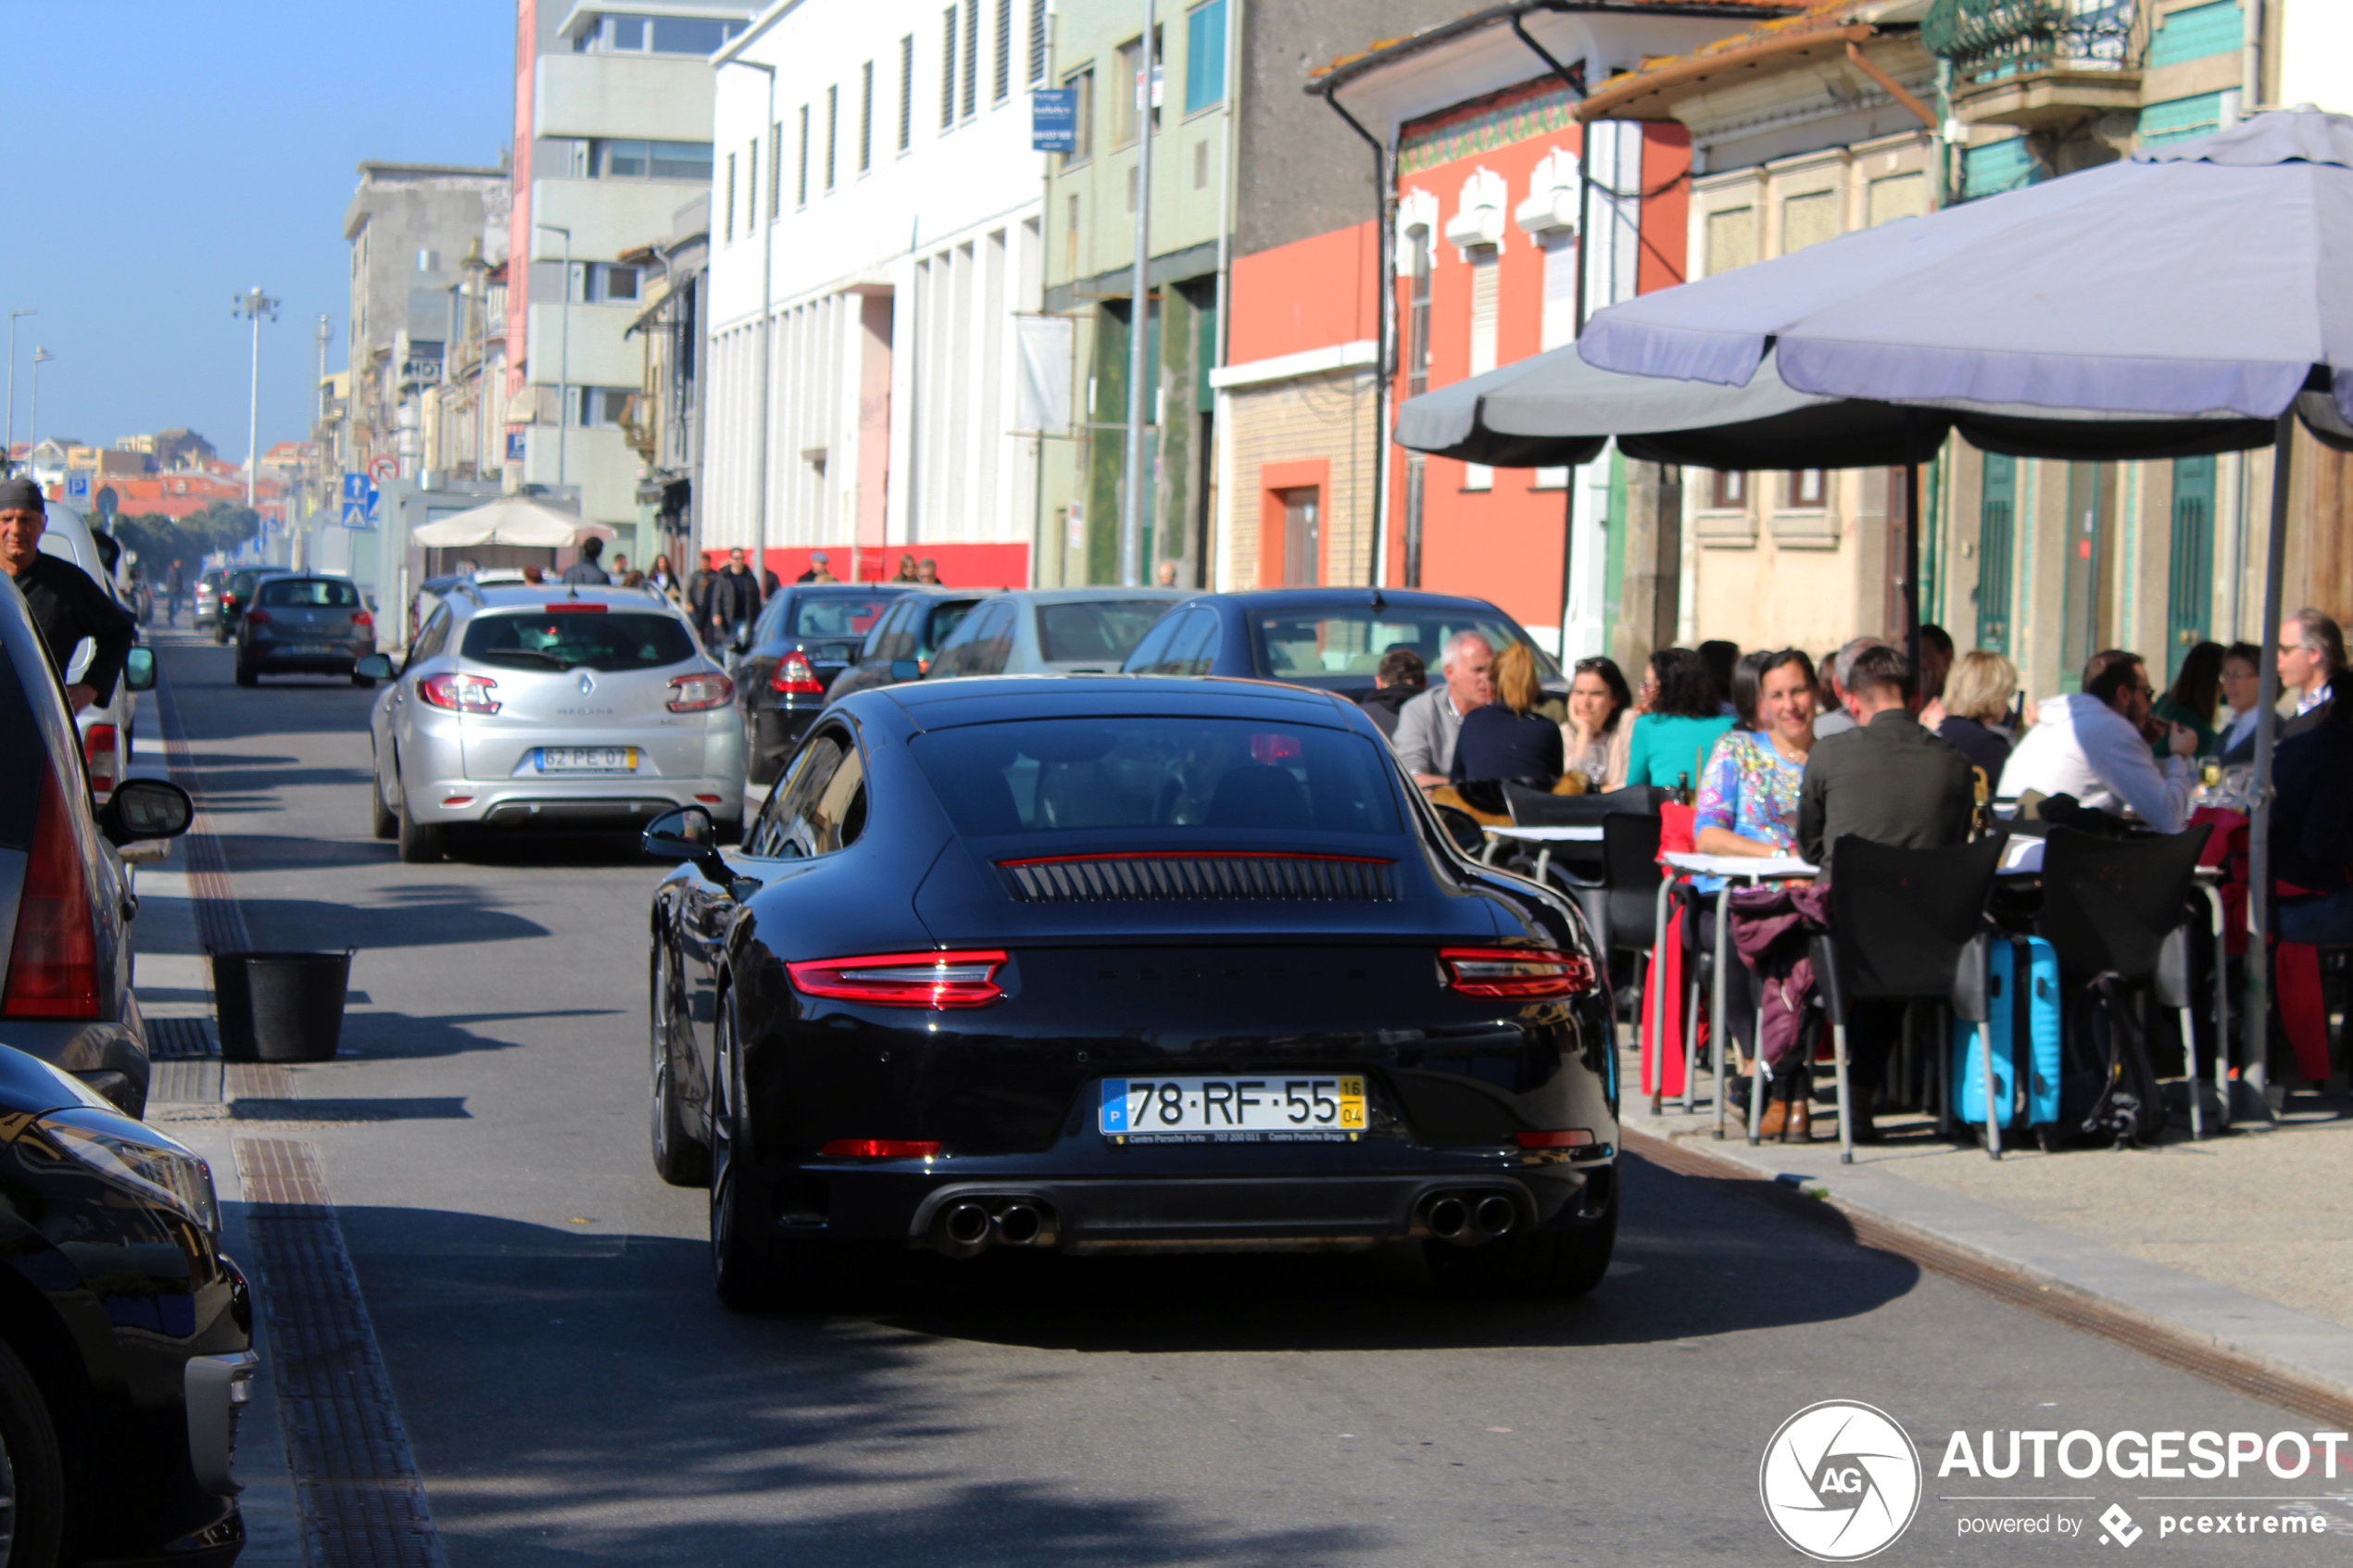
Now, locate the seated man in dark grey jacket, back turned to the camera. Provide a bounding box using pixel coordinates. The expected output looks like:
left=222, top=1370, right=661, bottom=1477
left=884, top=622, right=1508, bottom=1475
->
left=1765, top=644, right=1976, bottom=1143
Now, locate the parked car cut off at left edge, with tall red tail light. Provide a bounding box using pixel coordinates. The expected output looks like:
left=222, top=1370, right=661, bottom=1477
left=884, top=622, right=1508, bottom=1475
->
left=0, top=564, right=193, bottom=1117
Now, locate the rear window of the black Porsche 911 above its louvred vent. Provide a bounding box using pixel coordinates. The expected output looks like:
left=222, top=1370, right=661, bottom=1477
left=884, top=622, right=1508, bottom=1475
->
left=913, top=717, right=1400, bottom=839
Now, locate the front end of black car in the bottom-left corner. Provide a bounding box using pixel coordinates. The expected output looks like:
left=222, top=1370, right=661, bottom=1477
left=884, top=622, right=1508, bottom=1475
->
left=0, top=1022, right=254, bottom=1568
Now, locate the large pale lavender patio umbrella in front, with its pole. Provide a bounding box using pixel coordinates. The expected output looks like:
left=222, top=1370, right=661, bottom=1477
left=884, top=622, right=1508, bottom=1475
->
left=1579, top=108, right=2353, bottom=1110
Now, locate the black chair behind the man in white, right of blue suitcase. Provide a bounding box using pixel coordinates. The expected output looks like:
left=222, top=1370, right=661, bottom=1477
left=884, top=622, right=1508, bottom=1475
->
left=2035, top=822, right=2211, bottom=1138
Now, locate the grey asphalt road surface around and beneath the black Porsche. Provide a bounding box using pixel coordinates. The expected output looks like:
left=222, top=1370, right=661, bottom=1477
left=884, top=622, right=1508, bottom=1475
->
left=165, top=644, right=2353, bottom=1568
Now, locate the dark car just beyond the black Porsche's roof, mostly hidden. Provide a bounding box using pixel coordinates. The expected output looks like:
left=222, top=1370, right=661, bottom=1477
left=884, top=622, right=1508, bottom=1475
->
left=1120, top=588, right=1569, bottom=700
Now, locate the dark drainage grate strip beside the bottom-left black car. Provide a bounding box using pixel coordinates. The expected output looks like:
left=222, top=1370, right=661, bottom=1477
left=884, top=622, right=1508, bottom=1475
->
left=235, top=1138, right=445, bottom=1568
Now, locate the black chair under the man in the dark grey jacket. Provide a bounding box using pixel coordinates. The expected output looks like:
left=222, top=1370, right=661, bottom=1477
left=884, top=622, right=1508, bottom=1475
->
left=1797, top=834, right=2007, bottom=1163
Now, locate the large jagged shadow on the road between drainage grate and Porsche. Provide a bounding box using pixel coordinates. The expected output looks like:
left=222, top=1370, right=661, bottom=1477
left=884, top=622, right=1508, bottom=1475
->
left=336, top=1206, right=1390, bottom=1568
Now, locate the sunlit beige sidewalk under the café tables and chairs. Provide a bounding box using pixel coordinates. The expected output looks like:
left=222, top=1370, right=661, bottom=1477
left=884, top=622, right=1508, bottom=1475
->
left=1621, top=1051, right=2353, bottom=1399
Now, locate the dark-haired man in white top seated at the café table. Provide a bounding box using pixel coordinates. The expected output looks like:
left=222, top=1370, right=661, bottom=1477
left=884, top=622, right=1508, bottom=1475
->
left=1995, top=649, right=2197, bottom=833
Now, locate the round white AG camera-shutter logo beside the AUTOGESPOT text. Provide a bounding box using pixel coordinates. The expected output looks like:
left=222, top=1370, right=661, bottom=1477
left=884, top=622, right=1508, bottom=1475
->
left=1757, top=1399, right=1920, bottom=1563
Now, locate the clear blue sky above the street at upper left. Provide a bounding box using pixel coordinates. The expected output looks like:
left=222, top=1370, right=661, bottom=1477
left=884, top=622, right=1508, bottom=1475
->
left=17, top=0, right=515, bottom=463
